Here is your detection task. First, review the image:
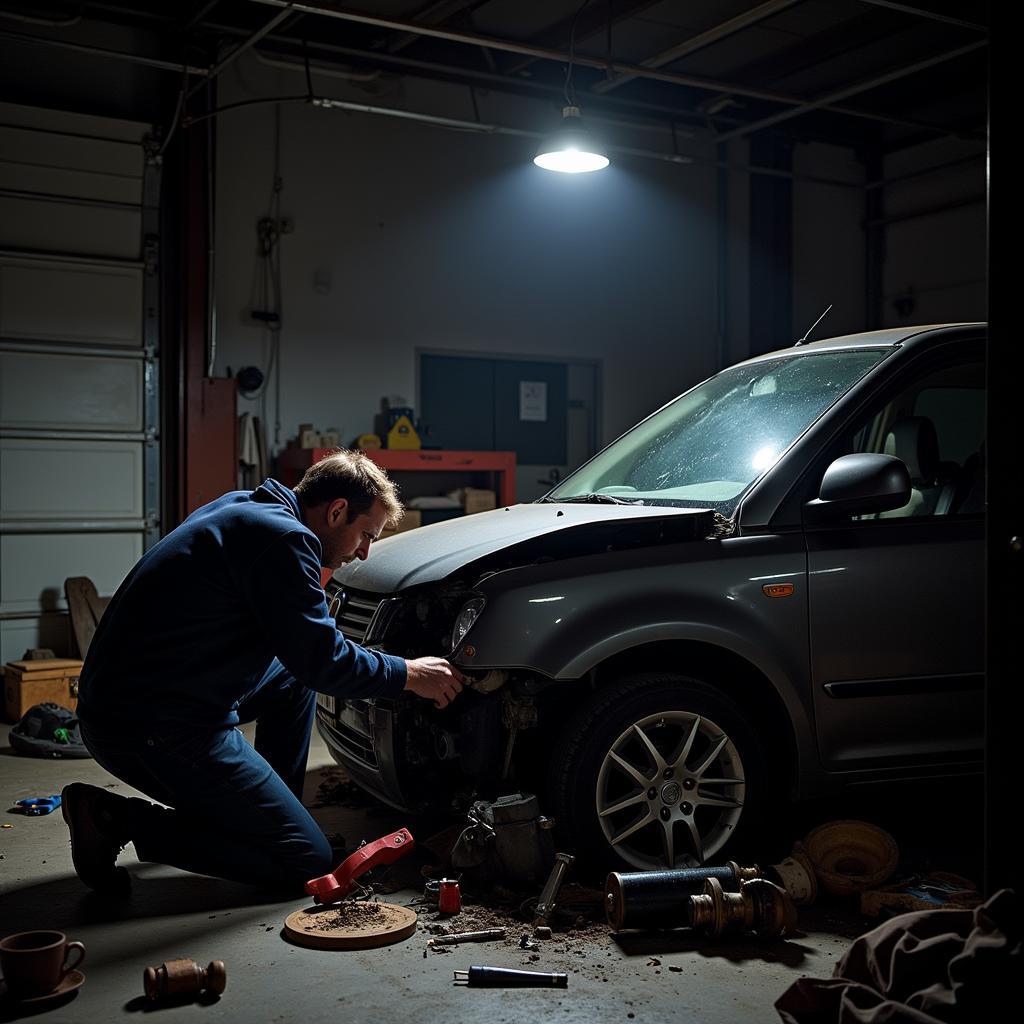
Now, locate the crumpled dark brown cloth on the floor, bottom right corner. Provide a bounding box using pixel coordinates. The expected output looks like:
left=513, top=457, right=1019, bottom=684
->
left=775, top=889, right=1024, bottom=1024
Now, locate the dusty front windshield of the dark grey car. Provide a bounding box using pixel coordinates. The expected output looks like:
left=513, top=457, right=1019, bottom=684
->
left=542, top=348, right=886, bottom=516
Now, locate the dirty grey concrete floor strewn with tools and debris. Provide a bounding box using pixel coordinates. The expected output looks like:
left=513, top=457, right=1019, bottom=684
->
left=0, top=727, right=980, bottom=1024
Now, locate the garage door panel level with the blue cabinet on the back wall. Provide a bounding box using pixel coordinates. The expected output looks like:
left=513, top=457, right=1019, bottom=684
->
left=0, top=351, right=142, bottom=431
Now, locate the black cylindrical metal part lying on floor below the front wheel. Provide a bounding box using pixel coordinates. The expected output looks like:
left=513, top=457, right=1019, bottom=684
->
left=604, top=860, right=761, bottom=932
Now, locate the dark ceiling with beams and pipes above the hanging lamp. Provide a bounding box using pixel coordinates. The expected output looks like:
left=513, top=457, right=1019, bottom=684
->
left=0, top=0, right=988, bottom=153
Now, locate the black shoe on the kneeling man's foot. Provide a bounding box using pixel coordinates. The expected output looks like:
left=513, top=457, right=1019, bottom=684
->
left=60, top=782, right=131, bottom=894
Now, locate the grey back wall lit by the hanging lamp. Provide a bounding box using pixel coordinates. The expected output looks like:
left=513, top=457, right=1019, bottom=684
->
left=216, top=58, right=717, bottom=466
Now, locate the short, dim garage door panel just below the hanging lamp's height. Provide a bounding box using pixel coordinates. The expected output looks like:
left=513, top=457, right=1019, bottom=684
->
left=0, top=197, right=142, bottom=259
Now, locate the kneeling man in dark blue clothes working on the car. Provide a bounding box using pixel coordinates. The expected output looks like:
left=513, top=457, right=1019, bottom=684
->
left=61, top=452, right=463, bottom=892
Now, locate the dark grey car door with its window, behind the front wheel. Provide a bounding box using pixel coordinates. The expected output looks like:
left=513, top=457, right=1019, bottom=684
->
left=805, top=343, right=985, bottom=770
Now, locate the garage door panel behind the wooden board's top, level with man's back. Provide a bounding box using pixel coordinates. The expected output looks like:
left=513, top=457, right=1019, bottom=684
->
left=0, top=532, right=142, bottom=615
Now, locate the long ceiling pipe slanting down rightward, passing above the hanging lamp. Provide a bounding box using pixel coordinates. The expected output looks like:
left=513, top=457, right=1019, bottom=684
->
left=241, top=0, right=966, bottom=135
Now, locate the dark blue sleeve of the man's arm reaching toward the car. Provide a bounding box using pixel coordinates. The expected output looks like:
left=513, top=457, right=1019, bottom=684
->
left=245, top=530, right=407, bottom=697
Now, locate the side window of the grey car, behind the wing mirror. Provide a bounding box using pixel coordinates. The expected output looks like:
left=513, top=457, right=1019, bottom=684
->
left=849, top=359, right=985, bottom=519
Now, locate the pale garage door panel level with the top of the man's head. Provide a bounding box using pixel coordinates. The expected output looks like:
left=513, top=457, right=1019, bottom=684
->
left=0, top=438, right=143, bottom=522
